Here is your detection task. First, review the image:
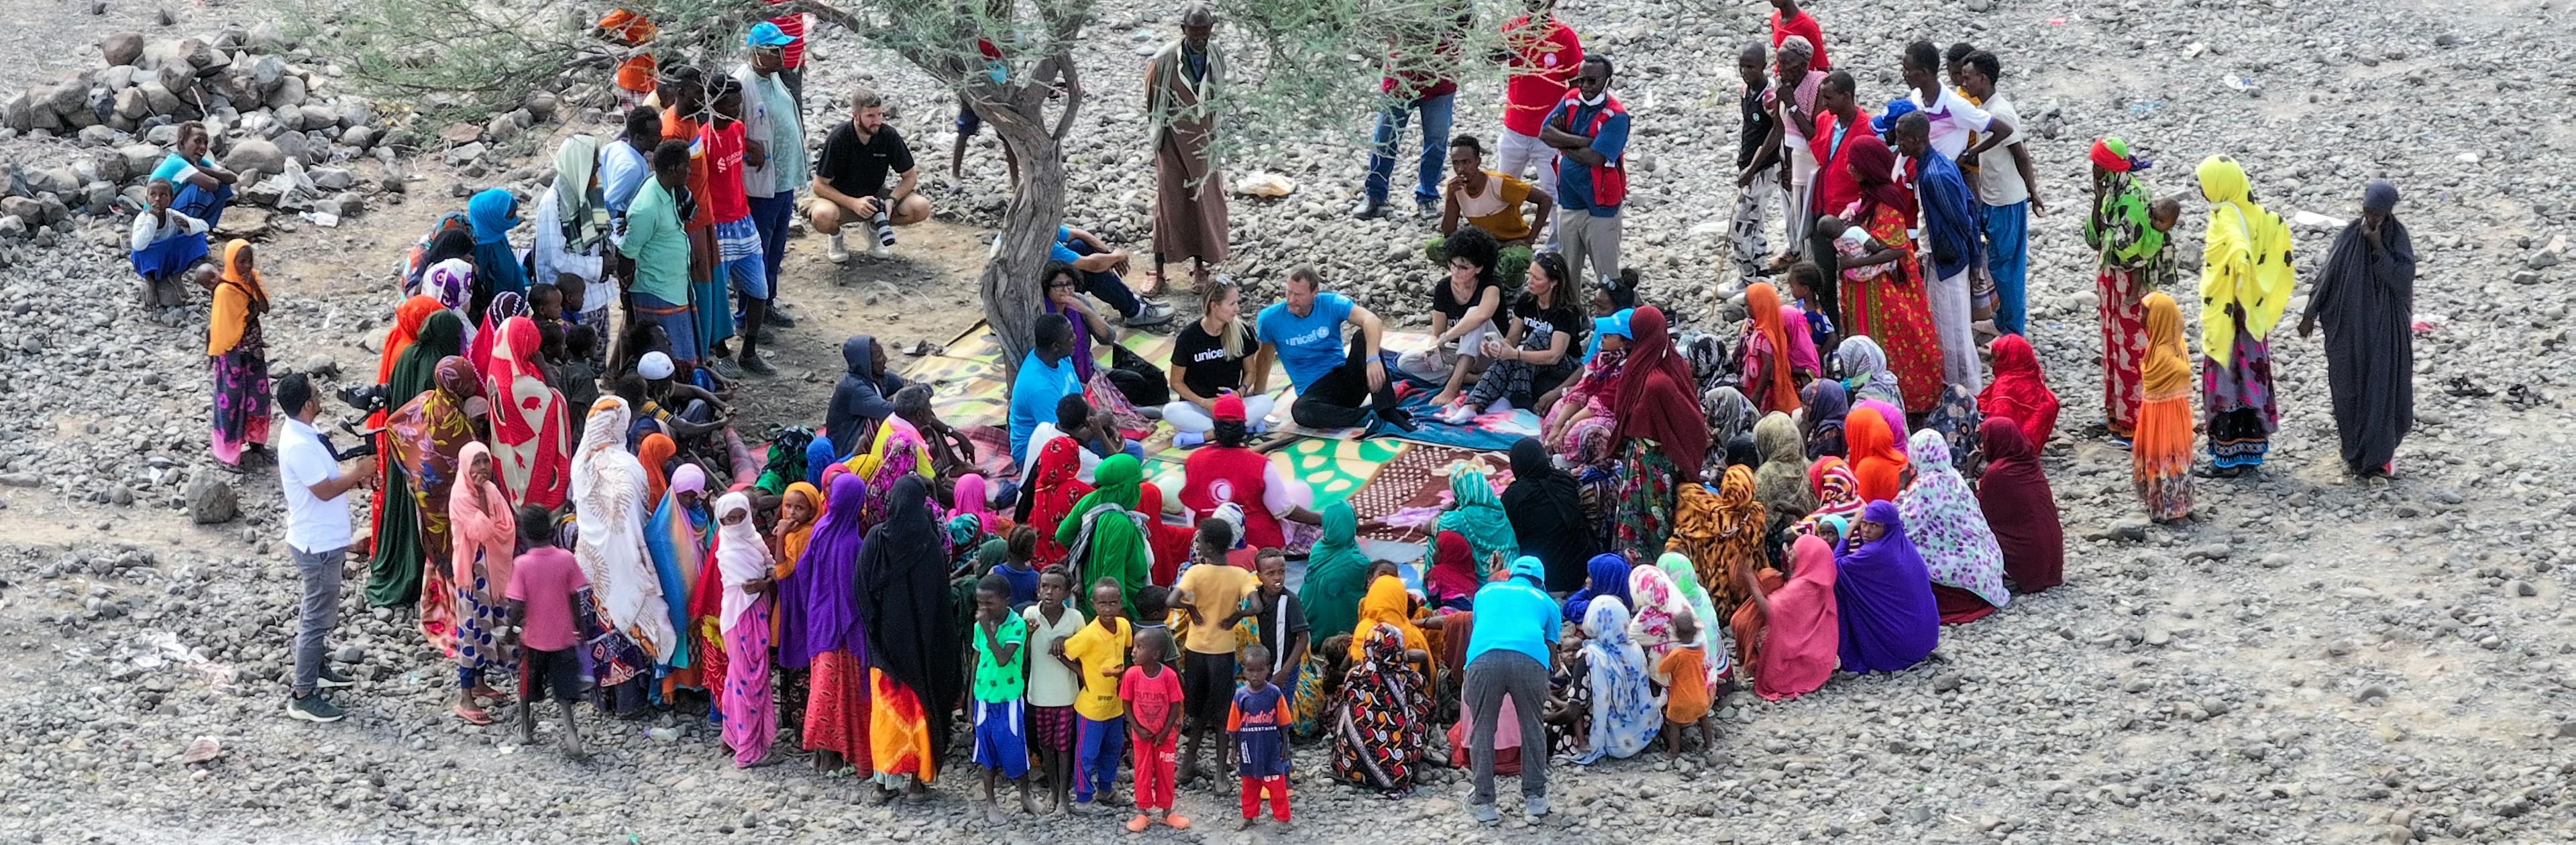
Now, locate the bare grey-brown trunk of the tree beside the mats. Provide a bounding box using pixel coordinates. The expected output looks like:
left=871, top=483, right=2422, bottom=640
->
left=976, top=121, right=1064, bottom=376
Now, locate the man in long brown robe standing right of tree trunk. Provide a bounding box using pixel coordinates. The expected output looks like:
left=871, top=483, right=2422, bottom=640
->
left=1144, top=3, right=1226, bottom=294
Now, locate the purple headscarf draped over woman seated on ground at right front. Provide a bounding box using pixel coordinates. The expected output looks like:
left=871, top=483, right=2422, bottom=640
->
left=1834, top=500, right=1940, bottom=673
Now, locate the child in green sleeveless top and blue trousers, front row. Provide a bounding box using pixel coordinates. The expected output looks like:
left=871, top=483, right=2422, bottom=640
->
left=969, top=572, right=1038, bottom=824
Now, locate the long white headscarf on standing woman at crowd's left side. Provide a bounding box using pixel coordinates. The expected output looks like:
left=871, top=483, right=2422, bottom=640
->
left=572, top=397, right=680, bottom=657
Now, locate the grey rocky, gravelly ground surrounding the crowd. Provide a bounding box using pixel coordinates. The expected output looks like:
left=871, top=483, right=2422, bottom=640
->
left=0, top=0, right=2576, bottom=842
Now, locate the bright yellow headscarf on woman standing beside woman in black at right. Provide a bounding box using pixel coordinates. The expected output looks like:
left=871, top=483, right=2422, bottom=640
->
left=2200, top=154, right=2298, bottom=365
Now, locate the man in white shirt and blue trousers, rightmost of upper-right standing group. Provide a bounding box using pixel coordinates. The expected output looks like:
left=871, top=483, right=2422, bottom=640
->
left=1953, top=49, right=2048, bottom=335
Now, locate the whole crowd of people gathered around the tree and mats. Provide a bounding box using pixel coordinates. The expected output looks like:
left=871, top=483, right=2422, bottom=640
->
left=134, top=0, right=2414, bottom=832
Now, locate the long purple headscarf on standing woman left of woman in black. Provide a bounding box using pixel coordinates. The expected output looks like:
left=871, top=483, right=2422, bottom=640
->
left=778, top=474, right=868, bottom=670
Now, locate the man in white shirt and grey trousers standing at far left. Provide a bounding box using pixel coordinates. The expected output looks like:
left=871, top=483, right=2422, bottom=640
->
left=278, top=374, right=376, bottom=722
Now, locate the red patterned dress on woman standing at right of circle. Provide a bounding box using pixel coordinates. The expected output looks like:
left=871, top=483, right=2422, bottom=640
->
left=1842, top=206, right=1942, bottom=414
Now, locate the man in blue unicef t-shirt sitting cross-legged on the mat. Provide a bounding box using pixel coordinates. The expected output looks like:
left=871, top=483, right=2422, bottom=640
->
left=1254, top=268, right=1414, bottom=431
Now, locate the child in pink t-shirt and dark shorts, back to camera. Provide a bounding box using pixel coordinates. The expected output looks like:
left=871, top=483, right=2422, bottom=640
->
left=505, top=505, right=590, bottom=757
